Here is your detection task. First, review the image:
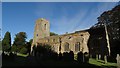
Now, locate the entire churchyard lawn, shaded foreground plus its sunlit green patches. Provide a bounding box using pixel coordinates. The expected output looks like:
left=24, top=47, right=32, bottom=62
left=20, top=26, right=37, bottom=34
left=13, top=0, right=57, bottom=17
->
left=4, top=53, right=117, bottom=68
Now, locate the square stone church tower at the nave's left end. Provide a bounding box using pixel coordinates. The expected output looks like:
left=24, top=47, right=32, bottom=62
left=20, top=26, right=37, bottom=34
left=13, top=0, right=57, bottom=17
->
left=32, top=18, right=50, bottom=51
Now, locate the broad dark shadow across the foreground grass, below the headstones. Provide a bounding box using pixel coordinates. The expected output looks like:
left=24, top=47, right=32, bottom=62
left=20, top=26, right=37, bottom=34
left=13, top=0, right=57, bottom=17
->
left=2, top=56, right=100, bottom=68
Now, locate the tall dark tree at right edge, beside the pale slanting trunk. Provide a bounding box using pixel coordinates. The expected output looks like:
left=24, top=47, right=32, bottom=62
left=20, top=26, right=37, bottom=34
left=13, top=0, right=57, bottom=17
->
left=91, top=4, right=120, bottom=60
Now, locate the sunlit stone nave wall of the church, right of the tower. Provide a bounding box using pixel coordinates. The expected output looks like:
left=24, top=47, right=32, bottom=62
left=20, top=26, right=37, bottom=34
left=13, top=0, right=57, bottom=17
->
left=35, top=31, right=90, bottom=54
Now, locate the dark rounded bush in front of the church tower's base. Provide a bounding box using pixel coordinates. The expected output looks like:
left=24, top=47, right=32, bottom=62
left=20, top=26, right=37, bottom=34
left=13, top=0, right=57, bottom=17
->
left=33, top=44, right=57, bottom=60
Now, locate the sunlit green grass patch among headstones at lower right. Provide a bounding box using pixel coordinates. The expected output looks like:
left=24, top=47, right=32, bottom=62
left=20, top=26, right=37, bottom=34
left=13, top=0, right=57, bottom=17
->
left=89, top=58, right=117, bottom=68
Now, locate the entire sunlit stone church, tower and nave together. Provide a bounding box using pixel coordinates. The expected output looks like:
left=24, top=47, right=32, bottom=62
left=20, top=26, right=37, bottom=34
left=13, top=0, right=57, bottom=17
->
left=31, top=18, right=90, bottom=54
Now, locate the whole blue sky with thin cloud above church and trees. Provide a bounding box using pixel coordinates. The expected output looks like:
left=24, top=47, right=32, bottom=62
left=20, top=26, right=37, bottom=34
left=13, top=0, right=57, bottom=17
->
left=2, top=2, right=116, bottom=41
